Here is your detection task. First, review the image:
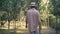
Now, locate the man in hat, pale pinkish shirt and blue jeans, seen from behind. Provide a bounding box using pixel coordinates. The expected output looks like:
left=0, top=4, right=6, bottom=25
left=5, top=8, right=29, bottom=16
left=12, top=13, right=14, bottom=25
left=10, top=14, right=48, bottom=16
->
left=26, top=2, right=41, bottom=34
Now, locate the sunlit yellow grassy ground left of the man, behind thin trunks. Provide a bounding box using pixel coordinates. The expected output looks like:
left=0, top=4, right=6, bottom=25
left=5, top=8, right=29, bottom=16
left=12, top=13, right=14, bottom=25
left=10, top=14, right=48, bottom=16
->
left=0, top=21, right=27, bottom=34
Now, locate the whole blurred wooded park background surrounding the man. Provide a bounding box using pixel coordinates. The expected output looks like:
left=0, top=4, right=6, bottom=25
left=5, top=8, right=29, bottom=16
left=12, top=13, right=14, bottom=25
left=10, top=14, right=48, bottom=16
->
left=0, top=0, right=60, bottom=34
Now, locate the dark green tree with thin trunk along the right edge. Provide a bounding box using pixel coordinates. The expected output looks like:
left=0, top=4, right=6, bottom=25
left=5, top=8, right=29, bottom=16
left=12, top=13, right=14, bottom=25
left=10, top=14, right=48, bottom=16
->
left=51, top=0, right=60, bottom=34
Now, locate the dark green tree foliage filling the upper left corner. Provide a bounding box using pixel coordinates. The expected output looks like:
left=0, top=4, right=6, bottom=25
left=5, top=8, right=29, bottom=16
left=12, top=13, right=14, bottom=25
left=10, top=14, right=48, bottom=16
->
left=0, top=0, right=21, bottom=20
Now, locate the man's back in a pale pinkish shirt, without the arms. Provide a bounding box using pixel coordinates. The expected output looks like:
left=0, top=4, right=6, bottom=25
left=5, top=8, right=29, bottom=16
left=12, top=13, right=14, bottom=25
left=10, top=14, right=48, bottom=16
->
left=27, top=8, right=40, bottom=31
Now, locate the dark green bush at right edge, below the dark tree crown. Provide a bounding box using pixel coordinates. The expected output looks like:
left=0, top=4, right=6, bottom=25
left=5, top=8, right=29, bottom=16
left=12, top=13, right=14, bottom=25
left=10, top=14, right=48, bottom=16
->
left=49, top=16, right=60, bottom=30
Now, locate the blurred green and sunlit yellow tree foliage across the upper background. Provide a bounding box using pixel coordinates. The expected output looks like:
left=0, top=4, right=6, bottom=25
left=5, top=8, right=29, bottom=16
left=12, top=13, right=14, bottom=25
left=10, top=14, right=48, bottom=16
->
left=0, top=0, right=60, bottom=27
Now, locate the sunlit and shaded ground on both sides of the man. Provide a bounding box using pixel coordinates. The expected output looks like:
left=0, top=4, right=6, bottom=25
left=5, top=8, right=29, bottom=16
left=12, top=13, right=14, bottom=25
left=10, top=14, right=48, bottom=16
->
left=0, top=23, right=59, bottom=34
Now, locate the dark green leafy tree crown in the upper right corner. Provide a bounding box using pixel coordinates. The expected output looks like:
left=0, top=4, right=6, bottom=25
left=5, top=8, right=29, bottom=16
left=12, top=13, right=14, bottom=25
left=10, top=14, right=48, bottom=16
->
left=52, top=1, right=60, bottom=16
